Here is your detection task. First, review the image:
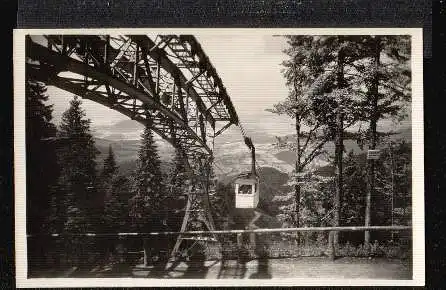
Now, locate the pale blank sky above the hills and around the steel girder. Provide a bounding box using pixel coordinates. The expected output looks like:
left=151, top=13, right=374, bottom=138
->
left=48, top=34, right=288, bottom=129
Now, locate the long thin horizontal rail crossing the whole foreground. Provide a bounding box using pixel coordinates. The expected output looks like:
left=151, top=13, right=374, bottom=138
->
left=27, top=226, right=412, bottom=237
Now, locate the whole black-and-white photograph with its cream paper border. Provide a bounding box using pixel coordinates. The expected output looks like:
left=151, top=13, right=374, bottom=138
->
left=14, top=28, right=424, bottom=287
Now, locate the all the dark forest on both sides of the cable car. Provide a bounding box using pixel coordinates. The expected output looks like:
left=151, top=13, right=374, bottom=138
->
left=26, top=36, right=412, bottom=274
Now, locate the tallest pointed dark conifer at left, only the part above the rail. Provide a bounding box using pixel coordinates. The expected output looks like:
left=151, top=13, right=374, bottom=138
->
left=59, top=96, right=101, bottom=232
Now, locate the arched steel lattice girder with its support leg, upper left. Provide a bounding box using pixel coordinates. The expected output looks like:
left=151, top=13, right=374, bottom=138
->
left=27, top=35, right=238, bottom=260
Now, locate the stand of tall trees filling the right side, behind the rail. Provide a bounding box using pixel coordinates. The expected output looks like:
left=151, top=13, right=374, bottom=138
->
left=269, top=36, right=411, bottom=248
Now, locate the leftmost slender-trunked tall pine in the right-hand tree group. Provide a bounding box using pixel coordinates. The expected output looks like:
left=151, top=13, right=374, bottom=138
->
left=268, top=36, right=330, bottom=231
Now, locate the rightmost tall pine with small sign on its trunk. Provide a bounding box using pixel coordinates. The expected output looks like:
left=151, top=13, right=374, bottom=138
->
left=359, top=35, right=411, bottom=245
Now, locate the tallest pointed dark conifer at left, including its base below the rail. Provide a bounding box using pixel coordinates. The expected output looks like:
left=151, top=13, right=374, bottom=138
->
left=53, top=96, right=99, bottom=265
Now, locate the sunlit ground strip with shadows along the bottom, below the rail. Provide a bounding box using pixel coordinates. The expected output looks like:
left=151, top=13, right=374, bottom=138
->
left=132, top=257, right=412, bottom=279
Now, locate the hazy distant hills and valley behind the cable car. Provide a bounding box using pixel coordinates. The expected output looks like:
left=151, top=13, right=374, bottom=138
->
left=90, top=117, right=411, bottom=228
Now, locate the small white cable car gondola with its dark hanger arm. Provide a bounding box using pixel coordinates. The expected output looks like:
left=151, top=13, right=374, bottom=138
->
left=235, top=137, right=260, bottom=208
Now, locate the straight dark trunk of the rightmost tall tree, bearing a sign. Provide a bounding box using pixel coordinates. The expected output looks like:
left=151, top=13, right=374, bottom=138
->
left=364, top=38, right=381, bottom=247
